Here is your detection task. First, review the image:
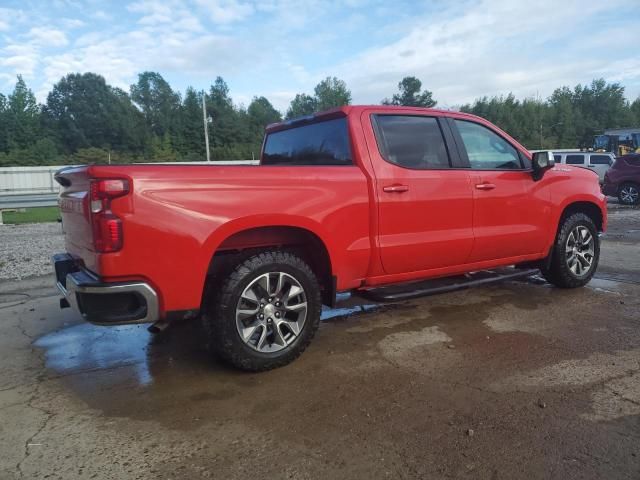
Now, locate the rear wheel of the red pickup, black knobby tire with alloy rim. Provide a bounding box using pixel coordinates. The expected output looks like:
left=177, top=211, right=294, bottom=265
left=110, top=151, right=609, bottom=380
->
left=203, top=251, right=321, bottom=371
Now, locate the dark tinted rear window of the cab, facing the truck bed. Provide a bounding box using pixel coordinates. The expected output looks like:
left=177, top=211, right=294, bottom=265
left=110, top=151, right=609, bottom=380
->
left=261, top=118, right=352, bottom=165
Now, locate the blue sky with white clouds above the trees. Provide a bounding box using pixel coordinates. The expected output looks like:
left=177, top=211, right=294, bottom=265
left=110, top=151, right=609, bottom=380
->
left=0, top=0, right=640, bottom=112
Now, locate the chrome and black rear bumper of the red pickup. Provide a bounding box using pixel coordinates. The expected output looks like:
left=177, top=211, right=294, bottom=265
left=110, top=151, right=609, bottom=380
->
left=52, top=253, right=160, bottom=325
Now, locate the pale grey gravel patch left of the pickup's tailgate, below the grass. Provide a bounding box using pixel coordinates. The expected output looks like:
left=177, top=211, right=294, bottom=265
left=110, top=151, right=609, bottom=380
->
left=0, top=223, right=64, bottom=281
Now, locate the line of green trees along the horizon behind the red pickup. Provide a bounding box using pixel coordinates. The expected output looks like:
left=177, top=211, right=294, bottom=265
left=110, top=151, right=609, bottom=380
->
left=0, top=72, right=640, bottom=166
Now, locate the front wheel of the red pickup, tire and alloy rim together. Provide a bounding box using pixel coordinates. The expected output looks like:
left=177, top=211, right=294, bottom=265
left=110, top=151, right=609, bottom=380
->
left=542, top=213, right=600, bottom=288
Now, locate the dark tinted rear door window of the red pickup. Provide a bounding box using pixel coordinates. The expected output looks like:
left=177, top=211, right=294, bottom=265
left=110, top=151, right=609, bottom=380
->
left=375, top=115, right=450, bottom=170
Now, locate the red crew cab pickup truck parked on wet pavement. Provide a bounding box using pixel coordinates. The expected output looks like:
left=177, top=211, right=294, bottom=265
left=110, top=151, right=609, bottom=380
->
left=54, top=106, right=607, bottom=371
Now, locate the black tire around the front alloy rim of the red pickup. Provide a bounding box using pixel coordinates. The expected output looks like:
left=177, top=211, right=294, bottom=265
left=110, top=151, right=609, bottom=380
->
left=541, top=213, right=600, bottom=288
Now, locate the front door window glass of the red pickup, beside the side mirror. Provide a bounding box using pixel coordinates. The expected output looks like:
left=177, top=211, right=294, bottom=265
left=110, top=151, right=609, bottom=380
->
left=455, top=120, right=522, bottom=170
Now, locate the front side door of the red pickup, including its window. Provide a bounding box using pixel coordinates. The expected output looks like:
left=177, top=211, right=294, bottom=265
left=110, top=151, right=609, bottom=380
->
left=449, top=119, right=551, bottom=263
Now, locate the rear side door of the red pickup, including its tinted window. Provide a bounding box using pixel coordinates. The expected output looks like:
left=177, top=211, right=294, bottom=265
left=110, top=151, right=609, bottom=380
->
left=362, top=111, right=473, bottom=274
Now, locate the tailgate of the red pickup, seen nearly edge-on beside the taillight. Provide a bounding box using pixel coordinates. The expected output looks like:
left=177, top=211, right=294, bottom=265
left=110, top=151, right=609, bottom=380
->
left=55, top=167, right=97, bottom=272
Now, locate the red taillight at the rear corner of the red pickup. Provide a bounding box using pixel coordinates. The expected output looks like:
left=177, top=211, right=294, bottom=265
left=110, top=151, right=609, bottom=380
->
left=89, top=178, right=129, bottom=253
